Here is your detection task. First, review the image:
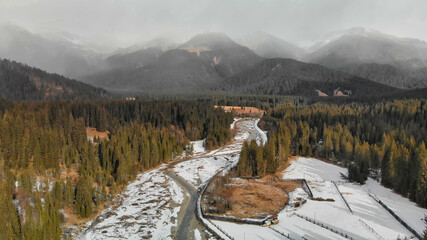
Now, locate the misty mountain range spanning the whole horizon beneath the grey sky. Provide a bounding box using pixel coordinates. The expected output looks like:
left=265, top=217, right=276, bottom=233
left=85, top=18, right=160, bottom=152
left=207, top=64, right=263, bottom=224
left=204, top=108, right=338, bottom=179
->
left=0, top=25, right=427, bottom=99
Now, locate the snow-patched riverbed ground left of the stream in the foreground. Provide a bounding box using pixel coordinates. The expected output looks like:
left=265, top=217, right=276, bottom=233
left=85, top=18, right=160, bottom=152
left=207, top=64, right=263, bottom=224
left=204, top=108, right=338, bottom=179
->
left=80, top=169, right=184, bottom=240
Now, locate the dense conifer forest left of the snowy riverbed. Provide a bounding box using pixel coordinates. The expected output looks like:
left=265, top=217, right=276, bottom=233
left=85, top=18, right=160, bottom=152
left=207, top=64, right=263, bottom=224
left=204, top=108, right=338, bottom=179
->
left=0, top=100, right=233, bottom=239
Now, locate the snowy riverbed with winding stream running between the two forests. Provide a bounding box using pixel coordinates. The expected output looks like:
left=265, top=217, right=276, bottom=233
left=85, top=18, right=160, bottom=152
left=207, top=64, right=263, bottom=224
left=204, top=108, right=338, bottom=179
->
left=79, top=119, right=266, bottom=240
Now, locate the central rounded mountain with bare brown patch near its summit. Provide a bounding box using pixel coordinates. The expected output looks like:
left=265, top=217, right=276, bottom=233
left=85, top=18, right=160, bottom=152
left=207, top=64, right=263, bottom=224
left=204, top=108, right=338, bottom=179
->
left=81, top=33, right=262, bottom=93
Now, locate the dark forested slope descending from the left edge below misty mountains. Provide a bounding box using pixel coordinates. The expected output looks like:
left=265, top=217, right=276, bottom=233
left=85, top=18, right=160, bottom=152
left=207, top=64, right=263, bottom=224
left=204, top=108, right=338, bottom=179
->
left=0, top=59, right=107, bottom=100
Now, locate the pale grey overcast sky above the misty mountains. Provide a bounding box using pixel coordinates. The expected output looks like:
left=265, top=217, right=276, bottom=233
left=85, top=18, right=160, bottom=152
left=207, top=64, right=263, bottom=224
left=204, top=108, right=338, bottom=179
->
left=0, top=0, right=427, bottom=47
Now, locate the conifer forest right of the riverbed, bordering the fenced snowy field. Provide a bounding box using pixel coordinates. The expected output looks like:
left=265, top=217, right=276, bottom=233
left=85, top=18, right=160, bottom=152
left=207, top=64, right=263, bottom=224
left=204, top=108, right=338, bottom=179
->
left=251, top=99, right=427, bottom=207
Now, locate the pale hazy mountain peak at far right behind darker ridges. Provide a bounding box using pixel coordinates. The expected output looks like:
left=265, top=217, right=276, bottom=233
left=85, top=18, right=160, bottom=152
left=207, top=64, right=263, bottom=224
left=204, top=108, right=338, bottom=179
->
left=304, top=28, right=427, bottom=68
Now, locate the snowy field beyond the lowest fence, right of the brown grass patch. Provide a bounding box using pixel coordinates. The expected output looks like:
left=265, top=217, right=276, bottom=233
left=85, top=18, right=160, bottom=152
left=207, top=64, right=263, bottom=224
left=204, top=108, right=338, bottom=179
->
left=283, top=158, right=427, bottom=239
